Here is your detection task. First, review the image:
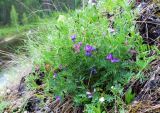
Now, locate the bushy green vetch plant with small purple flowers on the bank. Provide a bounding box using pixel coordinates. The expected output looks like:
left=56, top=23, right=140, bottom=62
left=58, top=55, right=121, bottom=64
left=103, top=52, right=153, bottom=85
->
left=26, top=0, right=158, bottom=113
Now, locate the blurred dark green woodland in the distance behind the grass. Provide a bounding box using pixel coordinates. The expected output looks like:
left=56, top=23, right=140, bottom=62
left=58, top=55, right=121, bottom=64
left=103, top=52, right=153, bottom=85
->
left=0, top=0, right=81, bottom=25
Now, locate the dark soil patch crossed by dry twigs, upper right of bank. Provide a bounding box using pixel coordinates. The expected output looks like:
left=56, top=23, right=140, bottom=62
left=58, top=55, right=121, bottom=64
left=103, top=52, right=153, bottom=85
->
left=137, top=3, right=160, bottom=47
